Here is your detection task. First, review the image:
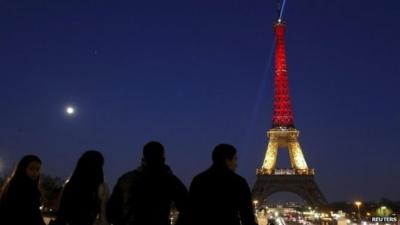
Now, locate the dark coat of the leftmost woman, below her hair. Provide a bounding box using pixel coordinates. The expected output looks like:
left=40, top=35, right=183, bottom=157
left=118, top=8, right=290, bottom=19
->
left=0, top=178, right=45, bottom=225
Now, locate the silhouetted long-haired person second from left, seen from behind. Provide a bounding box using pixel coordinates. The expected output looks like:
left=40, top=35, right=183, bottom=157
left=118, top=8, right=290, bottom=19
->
left=54, top=150, right=106, bottom=225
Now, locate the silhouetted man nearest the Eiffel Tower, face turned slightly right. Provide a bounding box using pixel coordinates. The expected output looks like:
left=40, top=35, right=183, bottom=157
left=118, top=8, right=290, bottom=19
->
left=189, top=144, right=257, bottom=225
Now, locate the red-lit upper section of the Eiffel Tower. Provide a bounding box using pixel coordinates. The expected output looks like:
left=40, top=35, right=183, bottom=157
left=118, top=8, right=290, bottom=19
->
left=272, top=19, right=294, bottom=128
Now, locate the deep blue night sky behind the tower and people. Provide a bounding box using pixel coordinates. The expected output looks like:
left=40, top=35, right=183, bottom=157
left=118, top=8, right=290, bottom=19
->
left=0, top=0, right=400, bottom=201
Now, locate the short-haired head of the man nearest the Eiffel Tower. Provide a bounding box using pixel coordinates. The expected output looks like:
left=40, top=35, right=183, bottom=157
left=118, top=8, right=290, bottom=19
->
left=212, top=144, right=237, bottom=171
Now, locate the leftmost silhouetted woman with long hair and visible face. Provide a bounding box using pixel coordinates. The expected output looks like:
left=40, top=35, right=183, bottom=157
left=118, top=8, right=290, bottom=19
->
left=0, top=155, right=45, bottom=225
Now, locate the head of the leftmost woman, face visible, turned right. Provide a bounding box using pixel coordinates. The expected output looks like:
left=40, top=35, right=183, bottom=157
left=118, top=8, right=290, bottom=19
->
left=12, top=155, right=42, bottom=181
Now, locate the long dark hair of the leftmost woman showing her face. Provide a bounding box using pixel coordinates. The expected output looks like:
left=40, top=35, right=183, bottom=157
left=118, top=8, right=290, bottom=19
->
left=0, top=155, right=42, bottom=199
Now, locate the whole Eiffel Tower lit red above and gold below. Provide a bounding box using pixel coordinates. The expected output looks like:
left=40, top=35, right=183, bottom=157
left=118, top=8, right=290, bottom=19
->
left=252, top=19, right=327, bottom=206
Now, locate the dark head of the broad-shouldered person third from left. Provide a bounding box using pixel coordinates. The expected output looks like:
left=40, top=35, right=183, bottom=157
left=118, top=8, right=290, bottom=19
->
left=143, top=141, right=165, bottom=167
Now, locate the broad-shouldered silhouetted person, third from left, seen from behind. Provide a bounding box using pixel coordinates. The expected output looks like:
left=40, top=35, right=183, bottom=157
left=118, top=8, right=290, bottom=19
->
left=106, top=141, right=188, bottom=225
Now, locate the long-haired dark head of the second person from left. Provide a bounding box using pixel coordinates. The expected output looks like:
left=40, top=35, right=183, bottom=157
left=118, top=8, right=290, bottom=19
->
left=69, top=150, right=104, bottom=188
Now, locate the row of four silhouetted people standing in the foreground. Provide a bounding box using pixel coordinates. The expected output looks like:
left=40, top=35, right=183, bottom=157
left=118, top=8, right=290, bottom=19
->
left=0, top=141, right=257, bottom=225
